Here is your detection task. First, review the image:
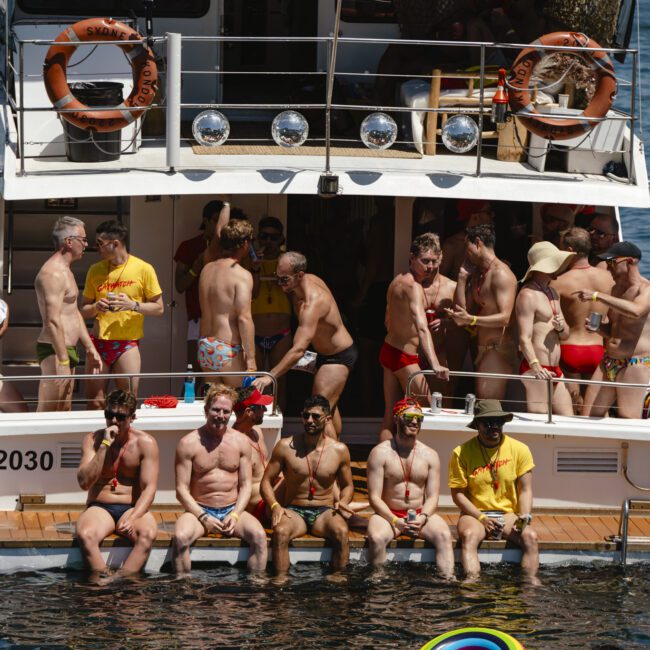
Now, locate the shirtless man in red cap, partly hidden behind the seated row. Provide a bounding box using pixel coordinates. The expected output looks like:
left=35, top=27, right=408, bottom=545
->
left=233, top=386, right=273, bottom=525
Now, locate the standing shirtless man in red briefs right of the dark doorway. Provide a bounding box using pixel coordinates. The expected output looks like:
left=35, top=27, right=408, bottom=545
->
left=379, top=233, right=449, bottom=442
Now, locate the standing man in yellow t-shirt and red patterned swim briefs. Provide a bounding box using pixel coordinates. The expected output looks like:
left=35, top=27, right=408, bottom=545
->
left=81, top=221, right=164, bottom=409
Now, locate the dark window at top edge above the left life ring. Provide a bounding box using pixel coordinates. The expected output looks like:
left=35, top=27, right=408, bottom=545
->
left=18, top=0, right=210, bottom=18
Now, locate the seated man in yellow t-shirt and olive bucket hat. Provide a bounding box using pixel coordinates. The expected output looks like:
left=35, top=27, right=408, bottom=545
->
left=448, top=399, right=539, bottom=583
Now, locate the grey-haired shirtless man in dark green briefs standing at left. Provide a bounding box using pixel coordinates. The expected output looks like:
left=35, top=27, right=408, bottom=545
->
left=35, top=217, right=102, bottom=411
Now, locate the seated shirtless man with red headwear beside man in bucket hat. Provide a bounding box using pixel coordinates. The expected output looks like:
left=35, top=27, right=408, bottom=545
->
left=368, top=398, right=454, bottom=580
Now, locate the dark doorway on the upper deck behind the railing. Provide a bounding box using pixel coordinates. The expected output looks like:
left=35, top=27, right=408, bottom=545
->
left=223, top=0, right=316, bottom=105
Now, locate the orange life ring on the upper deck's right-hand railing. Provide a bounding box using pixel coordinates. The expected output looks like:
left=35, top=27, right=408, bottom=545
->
left=508, top=32, right=617, bottom=140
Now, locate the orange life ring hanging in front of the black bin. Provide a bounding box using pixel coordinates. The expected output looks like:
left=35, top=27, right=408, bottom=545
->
left=43, top=18, right=158, bottom=133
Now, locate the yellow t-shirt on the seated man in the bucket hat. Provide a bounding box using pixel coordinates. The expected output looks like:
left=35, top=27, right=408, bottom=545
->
left=448, top=435, right=535, bottom=512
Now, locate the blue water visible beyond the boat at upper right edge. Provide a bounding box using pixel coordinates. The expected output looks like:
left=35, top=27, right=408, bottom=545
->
left=617, top=0, right=650, bottom=270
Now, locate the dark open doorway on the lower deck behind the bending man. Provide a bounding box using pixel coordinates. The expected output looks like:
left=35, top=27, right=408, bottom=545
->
left=286, top=196, right=395, bottom=421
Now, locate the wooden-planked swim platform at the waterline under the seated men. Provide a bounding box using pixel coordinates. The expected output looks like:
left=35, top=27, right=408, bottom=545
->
left=0, top=506, right=650, bottom=572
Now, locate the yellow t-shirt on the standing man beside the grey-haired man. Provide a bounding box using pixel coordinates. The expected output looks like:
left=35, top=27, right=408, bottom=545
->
left=84, top=255, right=162, bottom=341
